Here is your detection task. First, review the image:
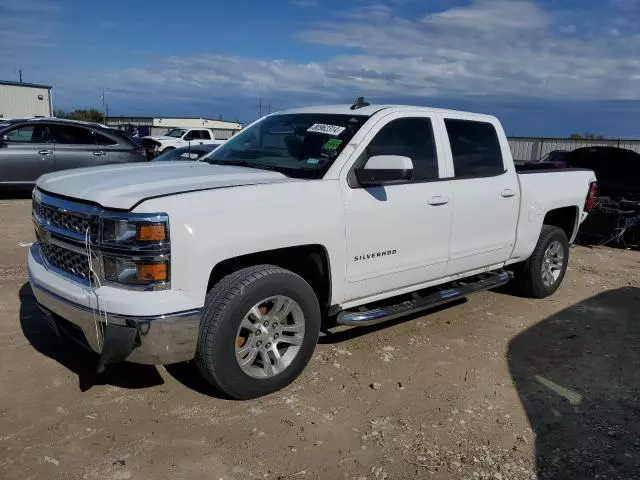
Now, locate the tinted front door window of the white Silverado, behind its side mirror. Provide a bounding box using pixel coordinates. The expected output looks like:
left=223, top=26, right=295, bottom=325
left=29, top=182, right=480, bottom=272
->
left=365, top=118, right=438, bottom=181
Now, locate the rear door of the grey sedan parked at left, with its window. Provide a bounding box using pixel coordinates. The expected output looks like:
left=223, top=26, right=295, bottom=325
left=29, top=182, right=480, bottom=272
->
left=54, top=124, right=108, bottom=170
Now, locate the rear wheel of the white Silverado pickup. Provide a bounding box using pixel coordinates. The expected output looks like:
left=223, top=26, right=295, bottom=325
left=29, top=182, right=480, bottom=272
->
left=515, top=225, right=569, bottom=298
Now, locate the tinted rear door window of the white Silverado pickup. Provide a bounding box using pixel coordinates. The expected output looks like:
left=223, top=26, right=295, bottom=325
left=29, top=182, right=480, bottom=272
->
left=444, top=119, right=504, bottom=177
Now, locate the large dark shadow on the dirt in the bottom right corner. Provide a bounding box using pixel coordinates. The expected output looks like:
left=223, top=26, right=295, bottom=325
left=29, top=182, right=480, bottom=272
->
left=508, top=287, right=640, bottom=480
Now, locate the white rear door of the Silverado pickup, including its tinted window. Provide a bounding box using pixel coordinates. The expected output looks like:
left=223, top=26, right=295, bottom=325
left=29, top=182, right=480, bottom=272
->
left=441, top=114, right=520, bottom=275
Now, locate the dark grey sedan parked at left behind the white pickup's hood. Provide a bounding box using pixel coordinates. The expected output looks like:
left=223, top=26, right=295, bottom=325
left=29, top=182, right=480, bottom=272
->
left=0, top=118, right=145, bottom=186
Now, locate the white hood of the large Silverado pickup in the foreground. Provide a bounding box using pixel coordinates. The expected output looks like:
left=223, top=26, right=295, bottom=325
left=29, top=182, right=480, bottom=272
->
left=36, top=162, right=296, bottom=210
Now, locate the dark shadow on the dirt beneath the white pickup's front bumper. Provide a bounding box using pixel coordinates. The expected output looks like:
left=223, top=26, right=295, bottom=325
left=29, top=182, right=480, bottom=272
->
left=19, top=283, right=164, bottom=392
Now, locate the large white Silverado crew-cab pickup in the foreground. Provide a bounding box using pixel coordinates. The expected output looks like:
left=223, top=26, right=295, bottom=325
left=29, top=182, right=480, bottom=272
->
left=28, top=102, right=596, bottom=399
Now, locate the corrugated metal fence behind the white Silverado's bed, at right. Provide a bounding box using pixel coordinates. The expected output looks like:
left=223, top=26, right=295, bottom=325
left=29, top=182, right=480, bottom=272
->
left=509, top=137, right=640, bottom=162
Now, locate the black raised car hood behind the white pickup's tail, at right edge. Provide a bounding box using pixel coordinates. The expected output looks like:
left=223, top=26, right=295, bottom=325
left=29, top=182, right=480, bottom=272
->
left=563, top=147, right=640, bottom=199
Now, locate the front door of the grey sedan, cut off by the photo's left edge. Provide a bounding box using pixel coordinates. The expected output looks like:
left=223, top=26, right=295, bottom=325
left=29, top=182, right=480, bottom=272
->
left=0, top=122, right=55, bottom=183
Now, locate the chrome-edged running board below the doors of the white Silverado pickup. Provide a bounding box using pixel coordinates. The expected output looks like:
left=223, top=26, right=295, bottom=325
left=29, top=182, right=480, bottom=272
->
left=336, top=270, right=509, bottom=326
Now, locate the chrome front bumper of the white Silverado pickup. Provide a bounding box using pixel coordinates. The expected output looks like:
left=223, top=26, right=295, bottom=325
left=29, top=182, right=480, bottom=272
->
left=29, top=272, right=202, bottom=365
